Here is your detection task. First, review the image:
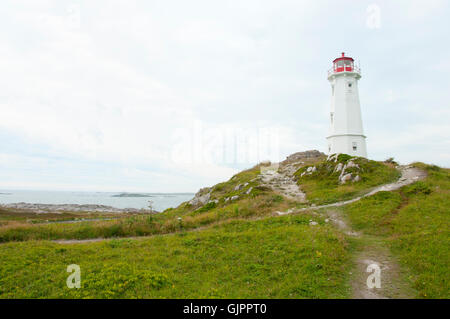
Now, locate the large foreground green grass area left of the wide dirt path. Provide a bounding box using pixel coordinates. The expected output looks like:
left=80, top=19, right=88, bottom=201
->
left=0, top=215, right=351, bottom=298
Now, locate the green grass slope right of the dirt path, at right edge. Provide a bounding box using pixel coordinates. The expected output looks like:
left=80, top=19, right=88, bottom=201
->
left=343, top=163, right=450, bottom=298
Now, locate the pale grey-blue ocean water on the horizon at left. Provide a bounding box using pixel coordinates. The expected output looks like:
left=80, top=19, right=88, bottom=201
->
left=0, top=190, right=194, bottom=211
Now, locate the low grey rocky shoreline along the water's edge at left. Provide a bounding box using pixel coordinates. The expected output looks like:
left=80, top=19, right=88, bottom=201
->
left=0, top=202, right=156, bottom=214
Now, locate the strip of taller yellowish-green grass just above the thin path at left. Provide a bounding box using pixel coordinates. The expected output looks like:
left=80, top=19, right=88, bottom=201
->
left=0, top=192, right=296, bottom=242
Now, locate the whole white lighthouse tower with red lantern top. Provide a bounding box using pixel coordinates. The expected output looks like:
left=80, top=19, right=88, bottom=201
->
left=327, top=53, right=367, bottom=157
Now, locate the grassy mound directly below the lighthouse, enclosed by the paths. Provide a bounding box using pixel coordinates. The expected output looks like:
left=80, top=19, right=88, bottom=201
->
left=295, top=154, right=400, bottom=205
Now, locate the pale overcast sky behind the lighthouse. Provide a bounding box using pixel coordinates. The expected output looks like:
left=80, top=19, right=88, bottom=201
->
left=0, top=0, right=450, bottom=192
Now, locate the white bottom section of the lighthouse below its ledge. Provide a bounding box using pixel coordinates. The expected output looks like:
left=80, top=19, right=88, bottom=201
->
left=327, top=134, right=367, bottom=158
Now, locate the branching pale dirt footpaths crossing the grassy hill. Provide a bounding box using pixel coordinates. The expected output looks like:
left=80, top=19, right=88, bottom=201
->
left=51, top=166, right=426, bottom=299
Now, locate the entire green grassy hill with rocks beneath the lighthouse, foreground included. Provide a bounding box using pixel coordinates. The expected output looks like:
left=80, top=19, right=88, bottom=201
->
left=0, top=154, right=450, bottom=298
